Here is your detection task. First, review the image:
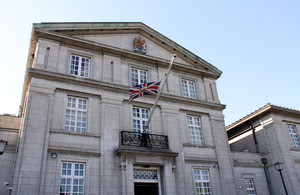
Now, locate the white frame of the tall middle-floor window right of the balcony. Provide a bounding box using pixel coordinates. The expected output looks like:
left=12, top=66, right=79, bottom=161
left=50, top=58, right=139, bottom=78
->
left=186, top=114, right=205, bottom=146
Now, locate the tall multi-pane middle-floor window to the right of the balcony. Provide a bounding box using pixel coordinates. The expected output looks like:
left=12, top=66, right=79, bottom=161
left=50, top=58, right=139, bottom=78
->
left=187, top=116, right=204, bottom=145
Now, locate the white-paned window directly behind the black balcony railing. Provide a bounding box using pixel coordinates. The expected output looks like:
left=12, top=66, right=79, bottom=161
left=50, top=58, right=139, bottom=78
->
left=132, top=107, right=150, bottom=133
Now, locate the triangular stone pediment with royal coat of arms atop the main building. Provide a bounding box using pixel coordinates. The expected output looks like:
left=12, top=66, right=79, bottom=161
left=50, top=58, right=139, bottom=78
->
left=34, top=23, right=222, bottom=77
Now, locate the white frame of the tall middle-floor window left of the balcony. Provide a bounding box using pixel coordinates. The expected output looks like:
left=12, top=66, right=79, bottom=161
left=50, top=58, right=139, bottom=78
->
left=64, top=95, right=88, bottom=134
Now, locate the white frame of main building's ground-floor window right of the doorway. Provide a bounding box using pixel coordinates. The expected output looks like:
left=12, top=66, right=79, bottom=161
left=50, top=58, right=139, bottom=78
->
left=193, top=167, right=212, bottom=195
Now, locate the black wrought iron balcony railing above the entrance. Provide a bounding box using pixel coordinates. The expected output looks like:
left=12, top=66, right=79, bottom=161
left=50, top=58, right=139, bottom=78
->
left=121, top=131, right=169, bottom=149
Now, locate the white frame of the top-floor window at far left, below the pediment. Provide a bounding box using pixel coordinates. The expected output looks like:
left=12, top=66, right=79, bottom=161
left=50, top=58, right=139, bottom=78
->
left=69, top=53, right=92, bottom=78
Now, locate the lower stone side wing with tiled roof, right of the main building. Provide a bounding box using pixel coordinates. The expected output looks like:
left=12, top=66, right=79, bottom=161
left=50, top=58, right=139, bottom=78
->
left=227, top=104, right=300, bottom=194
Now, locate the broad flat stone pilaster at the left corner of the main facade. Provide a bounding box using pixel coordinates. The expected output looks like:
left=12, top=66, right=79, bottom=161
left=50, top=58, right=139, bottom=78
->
left=12, top=82, right=54, bottom=195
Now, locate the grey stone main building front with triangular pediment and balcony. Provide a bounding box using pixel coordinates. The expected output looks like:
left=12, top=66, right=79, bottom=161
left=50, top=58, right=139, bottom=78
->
left=2, top=23, right=236, bottom=195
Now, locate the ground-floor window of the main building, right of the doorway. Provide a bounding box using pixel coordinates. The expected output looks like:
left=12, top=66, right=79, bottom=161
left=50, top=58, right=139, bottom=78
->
left=194, top=169, right=211, bottom=195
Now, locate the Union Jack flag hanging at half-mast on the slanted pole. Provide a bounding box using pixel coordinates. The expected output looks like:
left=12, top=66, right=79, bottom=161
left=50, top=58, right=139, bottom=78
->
left=129, top=81, right=160, bottom=102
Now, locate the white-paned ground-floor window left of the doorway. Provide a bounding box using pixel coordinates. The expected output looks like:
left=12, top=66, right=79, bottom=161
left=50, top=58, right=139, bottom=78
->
left=59, top=162, right=84, bottom=195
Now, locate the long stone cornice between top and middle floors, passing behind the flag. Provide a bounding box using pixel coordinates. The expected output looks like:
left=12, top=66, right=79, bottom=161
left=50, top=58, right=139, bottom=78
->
left=28, top=68, right=226, bottom=110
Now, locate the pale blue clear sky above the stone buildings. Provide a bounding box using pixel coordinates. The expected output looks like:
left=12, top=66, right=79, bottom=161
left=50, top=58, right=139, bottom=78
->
left=0, top=0, right=300, bottom=125
